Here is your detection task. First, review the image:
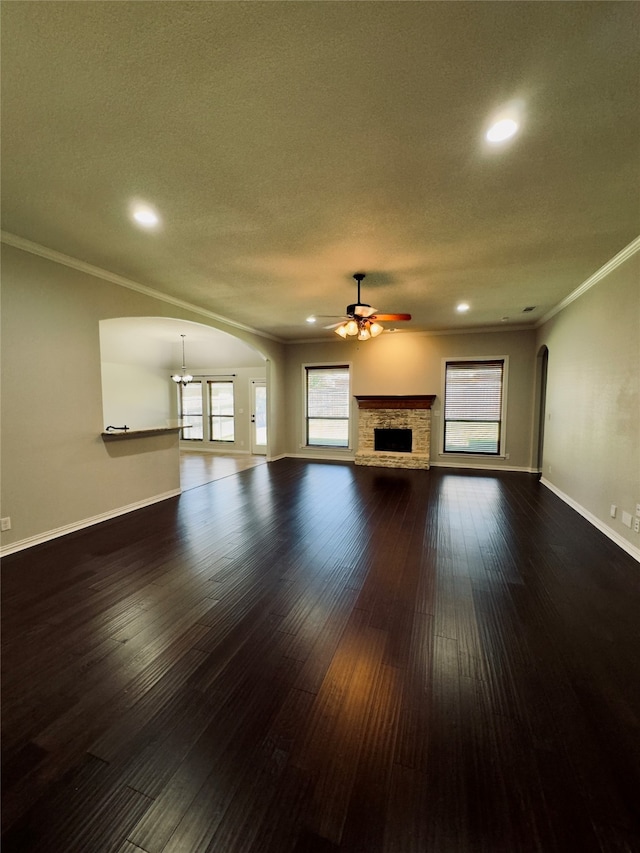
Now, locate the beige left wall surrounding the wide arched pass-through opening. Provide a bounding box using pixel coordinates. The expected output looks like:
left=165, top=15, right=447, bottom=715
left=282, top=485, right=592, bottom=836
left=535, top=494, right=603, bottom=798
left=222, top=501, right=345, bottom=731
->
left=1, top=245, right=285, bottom=550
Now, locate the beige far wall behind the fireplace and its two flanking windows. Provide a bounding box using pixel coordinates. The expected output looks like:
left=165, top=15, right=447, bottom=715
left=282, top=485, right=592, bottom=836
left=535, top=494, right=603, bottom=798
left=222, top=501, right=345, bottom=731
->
left=286, top=330, right=536, bottom=470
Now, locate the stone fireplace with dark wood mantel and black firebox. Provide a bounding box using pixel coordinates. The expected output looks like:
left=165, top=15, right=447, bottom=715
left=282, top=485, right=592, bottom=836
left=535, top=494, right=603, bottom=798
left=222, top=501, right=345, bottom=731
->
left=355, top=394, right=436, bottom=468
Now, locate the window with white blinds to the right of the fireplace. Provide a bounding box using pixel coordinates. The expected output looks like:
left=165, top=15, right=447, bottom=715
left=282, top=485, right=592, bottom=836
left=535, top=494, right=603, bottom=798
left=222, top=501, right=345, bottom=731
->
left=444, top=359, right=505, bottom=455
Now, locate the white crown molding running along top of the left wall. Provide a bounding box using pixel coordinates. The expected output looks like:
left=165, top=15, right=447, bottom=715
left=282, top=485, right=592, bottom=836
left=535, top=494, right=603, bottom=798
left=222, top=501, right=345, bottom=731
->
left=0, top=231, right=286, bottom=344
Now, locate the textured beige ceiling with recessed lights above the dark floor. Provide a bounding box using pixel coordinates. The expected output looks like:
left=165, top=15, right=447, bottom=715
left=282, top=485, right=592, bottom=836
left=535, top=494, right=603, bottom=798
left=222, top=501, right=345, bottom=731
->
left=2, top=0, right=640, bottom=345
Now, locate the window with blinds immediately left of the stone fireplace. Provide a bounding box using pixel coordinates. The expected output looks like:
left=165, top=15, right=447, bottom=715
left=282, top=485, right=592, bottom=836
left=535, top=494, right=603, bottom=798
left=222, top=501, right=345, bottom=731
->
left=305, top=364, right=350, bottom=447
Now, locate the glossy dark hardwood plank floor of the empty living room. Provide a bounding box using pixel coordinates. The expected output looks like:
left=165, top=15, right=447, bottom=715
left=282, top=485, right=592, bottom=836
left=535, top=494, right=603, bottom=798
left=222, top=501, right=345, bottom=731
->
left=2, top=460, right=640, bottom=853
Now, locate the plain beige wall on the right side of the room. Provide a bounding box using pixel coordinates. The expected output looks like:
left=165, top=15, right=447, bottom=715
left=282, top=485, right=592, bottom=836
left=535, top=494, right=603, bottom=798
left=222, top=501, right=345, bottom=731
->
left=537, top=252, right=640, bottom=551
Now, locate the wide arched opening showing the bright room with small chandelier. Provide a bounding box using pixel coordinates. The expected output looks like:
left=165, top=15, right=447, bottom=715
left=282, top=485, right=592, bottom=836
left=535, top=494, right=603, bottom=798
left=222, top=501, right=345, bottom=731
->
left=100, top=317, right=269, bottom=490
